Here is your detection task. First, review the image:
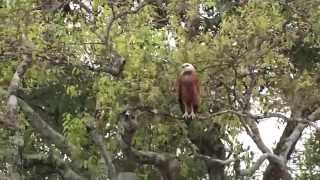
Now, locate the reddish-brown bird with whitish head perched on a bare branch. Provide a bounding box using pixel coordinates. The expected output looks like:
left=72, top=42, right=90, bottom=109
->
left=176, top=63, right=200, bottom=119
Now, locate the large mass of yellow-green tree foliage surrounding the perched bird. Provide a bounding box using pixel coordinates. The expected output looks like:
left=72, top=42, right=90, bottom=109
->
left=0, top=0, right=320, bottom=179
